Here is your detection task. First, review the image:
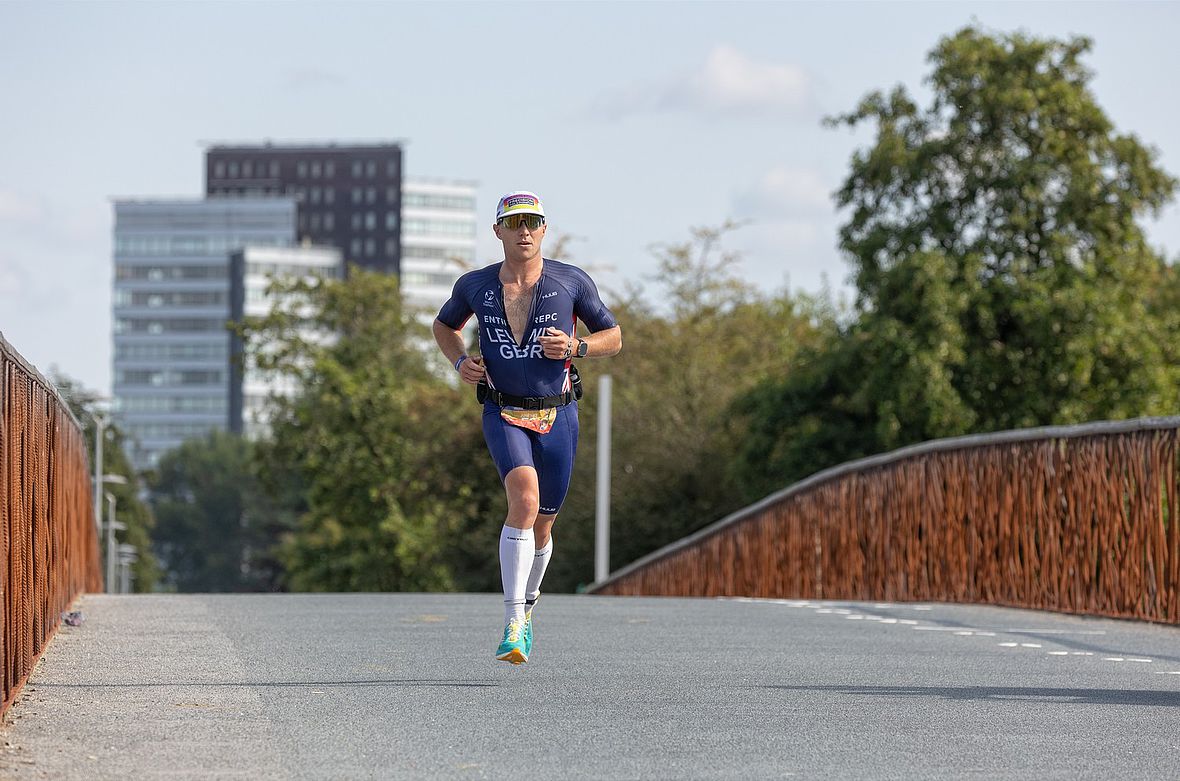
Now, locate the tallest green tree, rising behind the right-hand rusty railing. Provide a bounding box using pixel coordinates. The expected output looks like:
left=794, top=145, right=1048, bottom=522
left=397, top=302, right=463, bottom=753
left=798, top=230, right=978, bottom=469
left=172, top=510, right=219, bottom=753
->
left=742, top=27, right=1178, bottom=497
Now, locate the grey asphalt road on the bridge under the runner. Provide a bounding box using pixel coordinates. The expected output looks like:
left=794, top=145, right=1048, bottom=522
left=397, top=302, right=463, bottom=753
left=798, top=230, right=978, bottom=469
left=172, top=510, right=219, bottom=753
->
left=0, top=595, right=1180, bottom=781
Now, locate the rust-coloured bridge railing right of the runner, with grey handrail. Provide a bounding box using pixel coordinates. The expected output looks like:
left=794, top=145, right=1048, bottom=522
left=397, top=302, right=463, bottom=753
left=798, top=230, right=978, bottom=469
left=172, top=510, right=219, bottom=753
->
left=591, top=418, right=1180, bottom=624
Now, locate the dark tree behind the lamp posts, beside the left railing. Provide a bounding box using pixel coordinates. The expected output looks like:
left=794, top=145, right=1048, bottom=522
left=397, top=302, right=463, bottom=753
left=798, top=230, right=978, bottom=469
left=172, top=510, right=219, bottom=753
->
left=51, top=372, right=160, bottom=593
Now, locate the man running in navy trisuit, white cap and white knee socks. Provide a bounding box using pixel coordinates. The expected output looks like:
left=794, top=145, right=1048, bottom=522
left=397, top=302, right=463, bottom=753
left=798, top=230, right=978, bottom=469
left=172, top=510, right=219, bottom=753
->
left=434, top=191, right=623, bottom=664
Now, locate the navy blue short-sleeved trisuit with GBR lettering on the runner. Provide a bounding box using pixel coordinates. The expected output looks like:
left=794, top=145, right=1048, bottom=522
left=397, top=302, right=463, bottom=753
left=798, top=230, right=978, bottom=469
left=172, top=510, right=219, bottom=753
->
left=438, top=258, right=617, bottom=516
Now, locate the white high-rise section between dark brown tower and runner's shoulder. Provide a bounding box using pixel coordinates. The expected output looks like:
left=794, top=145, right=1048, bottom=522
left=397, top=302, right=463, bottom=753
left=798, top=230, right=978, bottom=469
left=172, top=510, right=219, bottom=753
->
left=401, top=178, right=476, bottom=320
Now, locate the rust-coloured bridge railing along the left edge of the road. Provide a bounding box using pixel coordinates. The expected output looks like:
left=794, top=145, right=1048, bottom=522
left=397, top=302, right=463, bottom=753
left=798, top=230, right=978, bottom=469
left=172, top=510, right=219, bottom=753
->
left=0, top=334, right=103, bottom=713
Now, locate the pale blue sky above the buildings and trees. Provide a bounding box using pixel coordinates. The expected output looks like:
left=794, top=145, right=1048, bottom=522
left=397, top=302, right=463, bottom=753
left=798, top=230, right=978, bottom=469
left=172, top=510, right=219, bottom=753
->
left=0, top=0, right=1180, bottom=394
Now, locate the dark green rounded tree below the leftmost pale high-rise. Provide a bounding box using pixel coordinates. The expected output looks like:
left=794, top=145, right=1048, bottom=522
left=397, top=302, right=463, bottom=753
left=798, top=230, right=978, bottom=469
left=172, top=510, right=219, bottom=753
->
left=150, top=431, right=288, bottom=591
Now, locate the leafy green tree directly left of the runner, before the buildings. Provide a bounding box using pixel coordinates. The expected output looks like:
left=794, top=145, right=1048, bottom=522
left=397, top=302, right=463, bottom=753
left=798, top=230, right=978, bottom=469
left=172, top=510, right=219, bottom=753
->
left=241, top=268, right=503, bottom=591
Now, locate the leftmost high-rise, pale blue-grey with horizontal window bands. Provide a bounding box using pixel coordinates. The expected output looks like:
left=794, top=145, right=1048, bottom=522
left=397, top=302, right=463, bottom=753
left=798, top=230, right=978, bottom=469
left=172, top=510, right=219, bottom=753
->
left=112, top=196, right=296, bottom=470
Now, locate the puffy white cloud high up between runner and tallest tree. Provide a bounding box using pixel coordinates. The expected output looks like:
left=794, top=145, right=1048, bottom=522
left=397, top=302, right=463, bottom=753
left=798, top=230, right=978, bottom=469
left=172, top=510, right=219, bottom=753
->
left=594, top=44, right=812, bottom=119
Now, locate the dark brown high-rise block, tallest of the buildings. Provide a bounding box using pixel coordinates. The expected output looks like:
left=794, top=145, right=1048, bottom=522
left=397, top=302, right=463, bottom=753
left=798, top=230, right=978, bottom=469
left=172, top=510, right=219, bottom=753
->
left=205, top=143, right=401, bottom=274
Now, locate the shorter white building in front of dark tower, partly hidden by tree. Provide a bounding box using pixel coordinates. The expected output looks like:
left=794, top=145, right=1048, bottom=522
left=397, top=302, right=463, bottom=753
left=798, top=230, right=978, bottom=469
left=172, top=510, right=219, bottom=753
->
left=229, top=247, right=341, bottom=439
